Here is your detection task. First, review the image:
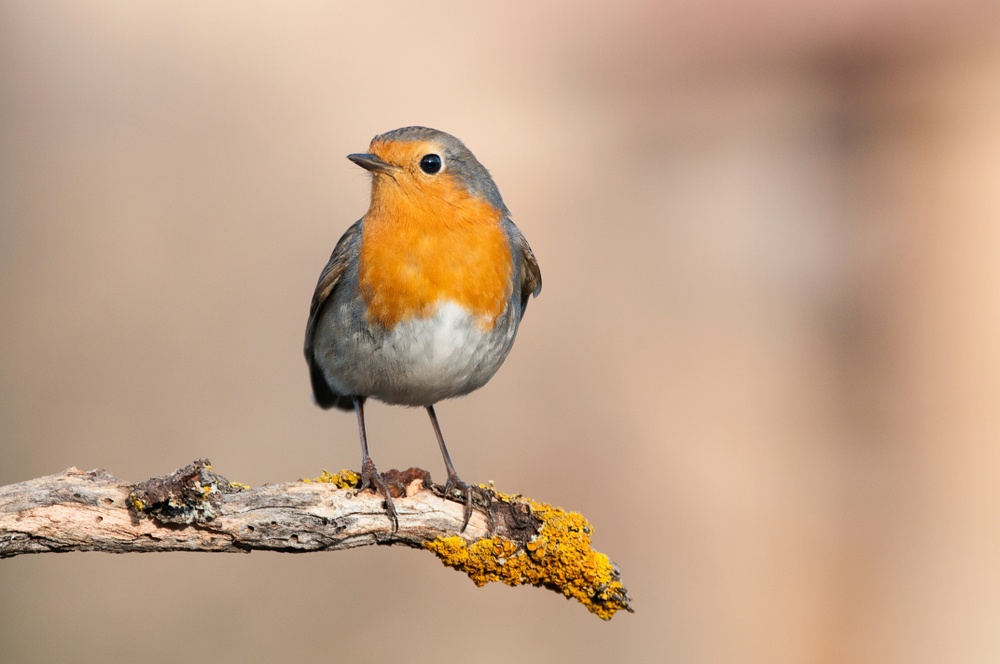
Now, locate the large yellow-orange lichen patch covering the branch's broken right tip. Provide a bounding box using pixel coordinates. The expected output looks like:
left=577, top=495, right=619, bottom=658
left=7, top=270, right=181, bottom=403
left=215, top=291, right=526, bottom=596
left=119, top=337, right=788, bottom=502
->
left=424, top=487, right=631, bottom=620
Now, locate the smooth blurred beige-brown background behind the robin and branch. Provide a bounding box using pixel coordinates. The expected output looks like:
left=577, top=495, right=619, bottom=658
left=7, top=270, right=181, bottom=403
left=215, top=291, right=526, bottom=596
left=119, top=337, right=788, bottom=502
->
left=0, top=0, right=1000, bottom=663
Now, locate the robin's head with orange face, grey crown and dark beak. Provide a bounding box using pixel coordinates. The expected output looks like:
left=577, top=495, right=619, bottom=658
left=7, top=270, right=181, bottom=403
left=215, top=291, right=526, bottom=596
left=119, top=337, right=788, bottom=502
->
left=347, top=127, right=508, bottom=215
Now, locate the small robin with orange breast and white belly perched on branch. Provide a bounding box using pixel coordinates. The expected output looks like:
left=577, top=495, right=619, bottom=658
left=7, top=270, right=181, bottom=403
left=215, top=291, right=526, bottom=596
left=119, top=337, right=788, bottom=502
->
left=305, top=126, right=542, bottom=533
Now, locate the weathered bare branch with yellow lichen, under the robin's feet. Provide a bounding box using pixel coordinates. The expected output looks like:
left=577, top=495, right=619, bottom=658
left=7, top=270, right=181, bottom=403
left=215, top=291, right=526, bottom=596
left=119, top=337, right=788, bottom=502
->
left=0, top=459, right=632, bottom=620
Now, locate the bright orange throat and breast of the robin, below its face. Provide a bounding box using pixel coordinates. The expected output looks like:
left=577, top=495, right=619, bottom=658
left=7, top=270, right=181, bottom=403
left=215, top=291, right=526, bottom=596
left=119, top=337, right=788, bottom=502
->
left=358, top=174, right=513, bottom=329
